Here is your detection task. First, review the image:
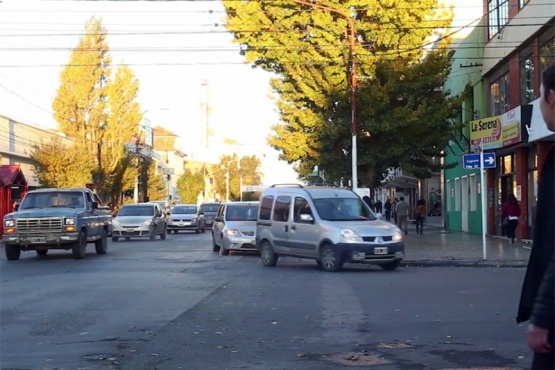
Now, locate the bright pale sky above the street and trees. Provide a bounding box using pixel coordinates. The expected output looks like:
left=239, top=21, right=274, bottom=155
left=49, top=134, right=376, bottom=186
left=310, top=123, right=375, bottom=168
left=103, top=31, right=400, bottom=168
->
left=0, top=0, right=482, bottom=185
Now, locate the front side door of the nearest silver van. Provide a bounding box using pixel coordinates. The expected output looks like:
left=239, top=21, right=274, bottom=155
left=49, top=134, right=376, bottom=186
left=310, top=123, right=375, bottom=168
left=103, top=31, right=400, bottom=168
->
left=289, top=196, right=320, bottom=258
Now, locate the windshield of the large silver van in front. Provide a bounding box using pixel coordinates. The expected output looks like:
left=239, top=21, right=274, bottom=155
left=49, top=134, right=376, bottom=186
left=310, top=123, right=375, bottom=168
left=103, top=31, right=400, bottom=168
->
left=314, top=198, right=377, bottom=221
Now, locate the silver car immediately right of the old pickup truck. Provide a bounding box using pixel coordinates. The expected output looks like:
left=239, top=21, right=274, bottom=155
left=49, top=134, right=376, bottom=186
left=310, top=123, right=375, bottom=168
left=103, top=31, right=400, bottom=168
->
left=112, top=203, right=167, bottom=242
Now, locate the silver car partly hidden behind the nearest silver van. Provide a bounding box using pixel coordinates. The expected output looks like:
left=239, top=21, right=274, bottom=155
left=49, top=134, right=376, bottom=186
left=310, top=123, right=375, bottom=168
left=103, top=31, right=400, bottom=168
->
left=212, top=202, right=260, bottom=256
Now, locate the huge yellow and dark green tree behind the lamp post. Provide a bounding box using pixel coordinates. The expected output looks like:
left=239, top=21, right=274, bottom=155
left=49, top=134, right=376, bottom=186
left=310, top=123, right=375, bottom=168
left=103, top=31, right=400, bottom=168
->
left=224, top=0, right=462, bottom=184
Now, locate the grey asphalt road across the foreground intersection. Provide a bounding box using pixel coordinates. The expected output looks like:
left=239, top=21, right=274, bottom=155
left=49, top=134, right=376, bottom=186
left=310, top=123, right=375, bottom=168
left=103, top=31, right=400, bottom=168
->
left=0, top=232, right=530, bottom=370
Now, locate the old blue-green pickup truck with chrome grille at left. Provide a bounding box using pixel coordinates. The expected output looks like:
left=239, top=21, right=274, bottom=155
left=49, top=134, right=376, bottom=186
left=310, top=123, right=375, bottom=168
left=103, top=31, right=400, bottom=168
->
left=2, top=188, right=112, bottom=260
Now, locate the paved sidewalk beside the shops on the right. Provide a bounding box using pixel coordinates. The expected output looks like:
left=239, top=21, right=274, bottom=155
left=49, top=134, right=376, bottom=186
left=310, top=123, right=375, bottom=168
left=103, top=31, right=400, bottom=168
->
left=402, top=217, right=530, bottom=267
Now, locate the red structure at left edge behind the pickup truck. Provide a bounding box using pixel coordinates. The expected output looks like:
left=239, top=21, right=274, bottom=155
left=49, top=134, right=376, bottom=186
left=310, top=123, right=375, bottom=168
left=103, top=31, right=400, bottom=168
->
left=0, top=165, right=28, bottom=235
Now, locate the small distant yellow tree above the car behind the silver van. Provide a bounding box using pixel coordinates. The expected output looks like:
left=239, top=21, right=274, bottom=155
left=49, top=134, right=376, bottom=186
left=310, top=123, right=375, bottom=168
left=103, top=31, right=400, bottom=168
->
left=211, top=153, right=262, bottom=200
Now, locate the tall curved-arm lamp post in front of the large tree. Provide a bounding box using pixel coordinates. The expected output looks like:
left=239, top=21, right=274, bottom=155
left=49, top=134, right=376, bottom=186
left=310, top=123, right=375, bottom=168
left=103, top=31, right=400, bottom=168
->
left=291, top=0, right=358, bottom=190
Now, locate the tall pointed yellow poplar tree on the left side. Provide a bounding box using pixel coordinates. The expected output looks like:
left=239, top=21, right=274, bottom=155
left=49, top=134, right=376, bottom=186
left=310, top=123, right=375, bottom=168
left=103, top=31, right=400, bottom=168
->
left=52, top=17, right=142, bottom=199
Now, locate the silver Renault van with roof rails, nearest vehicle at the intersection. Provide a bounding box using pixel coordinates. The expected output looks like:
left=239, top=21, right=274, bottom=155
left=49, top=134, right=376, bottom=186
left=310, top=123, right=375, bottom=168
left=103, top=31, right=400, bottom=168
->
left=256, top=185, right=405, bottom=271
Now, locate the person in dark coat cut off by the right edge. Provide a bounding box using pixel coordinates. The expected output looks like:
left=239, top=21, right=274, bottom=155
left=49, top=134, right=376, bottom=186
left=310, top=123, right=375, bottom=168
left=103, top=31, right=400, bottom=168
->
left=516, top=63, right=555, bottom=370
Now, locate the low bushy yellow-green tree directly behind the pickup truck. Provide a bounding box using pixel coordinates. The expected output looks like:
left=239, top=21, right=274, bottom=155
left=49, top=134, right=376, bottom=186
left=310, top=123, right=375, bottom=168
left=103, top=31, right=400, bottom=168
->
left=30, top=138, right=94, bottom=188
